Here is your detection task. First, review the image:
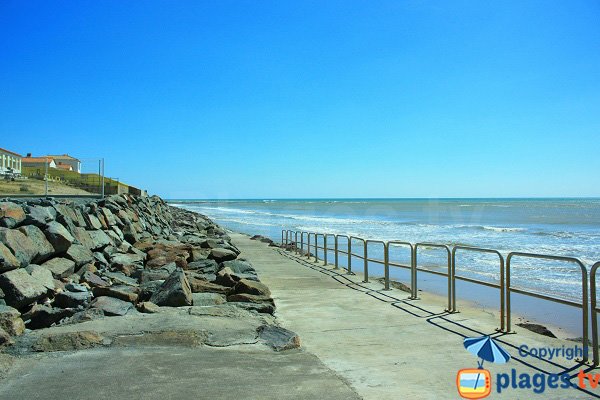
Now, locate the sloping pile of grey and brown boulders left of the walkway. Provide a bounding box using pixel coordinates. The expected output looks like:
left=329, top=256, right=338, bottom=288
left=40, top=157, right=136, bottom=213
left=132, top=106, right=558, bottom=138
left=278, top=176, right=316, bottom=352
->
left=0, top=195, right=275, bottom=346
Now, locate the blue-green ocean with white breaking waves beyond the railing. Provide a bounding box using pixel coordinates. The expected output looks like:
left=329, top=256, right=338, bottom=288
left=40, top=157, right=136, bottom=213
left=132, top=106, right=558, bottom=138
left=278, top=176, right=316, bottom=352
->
left=172, top=198, right=600, bottom=301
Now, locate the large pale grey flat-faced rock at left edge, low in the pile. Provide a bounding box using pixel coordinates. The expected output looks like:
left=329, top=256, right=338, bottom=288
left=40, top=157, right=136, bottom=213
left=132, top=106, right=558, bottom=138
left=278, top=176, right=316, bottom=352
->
left=0, top=268, right=48, bottom=309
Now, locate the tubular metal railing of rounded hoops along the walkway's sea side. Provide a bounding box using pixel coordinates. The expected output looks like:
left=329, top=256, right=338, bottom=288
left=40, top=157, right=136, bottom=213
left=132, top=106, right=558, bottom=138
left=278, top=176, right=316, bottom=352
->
left=281, top=230, right=600, bottom=365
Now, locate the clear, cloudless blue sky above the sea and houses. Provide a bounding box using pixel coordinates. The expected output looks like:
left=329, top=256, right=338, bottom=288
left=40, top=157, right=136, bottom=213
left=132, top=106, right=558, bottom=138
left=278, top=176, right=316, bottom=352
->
left=0, top=0, right=600, bottom=198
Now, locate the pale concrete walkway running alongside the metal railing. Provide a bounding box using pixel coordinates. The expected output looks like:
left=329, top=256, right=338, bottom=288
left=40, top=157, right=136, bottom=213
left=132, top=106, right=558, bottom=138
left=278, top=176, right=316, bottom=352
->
left=231, top=234, right=600, bottom=400
